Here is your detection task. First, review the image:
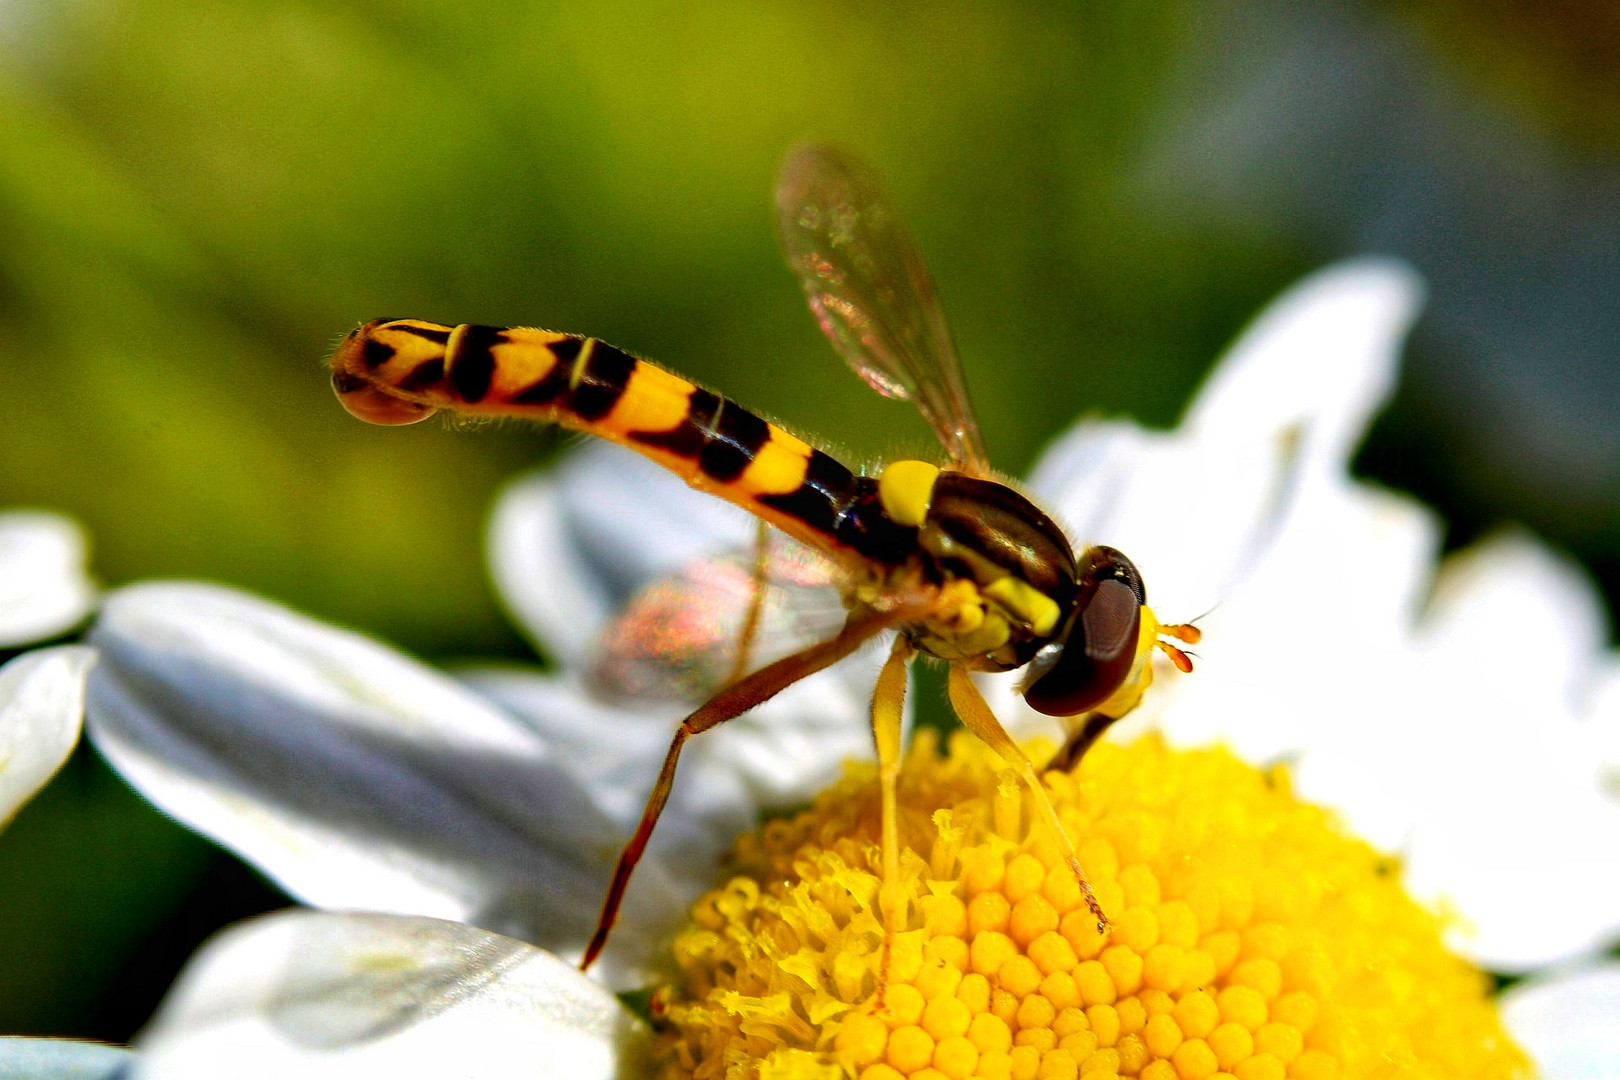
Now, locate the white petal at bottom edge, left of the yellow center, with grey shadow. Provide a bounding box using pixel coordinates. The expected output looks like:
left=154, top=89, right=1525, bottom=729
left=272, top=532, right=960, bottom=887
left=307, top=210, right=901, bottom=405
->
left=136, top=912, right=646, bottom=1080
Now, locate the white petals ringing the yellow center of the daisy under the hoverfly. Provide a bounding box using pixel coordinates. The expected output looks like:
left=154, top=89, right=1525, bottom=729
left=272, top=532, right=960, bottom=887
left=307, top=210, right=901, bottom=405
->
left=69, top=262, right=1620, bottom=1075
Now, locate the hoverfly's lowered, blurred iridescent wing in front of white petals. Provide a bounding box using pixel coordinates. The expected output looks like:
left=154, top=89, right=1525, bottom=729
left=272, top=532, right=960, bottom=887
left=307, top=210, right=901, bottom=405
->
left=590, top=534, right=849, bottom=704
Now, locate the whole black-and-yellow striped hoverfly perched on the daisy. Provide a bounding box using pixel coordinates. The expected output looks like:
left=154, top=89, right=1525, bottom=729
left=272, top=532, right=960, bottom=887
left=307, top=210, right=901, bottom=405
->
left=332, top=146, right=1199, bottom=968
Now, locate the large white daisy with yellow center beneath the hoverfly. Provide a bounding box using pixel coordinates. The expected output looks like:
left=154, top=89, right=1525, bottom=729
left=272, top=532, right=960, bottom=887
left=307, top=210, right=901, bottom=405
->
left=9, top=262, right=1620, bottom=1080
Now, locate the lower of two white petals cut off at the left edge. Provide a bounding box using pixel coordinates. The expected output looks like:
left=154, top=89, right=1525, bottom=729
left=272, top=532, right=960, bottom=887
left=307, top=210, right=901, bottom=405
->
left=0, top=644, right=96, bottom=827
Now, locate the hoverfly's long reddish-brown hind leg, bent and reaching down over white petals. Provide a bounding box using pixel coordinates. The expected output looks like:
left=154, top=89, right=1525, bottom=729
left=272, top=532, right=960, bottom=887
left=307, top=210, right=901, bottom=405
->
left=580, top=609, right=902, bottom=972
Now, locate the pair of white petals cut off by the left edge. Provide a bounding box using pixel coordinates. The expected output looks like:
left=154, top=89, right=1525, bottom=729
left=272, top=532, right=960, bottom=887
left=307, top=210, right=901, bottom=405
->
left=0, top=510, right=96, bottom=829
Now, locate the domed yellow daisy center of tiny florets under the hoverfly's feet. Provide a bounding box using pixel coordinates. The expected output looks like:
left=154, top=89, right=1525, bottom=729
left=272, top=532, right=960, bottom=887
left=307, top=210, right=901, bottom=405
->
left=654, top=732, right=1529, bottom=1080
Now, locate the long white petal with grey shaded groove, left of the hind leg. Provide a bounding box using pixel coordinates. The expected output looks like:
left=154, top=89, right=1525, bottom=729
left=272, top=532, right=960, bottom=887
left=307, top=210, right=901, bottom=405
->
left=89, top=583, right=670, bottom=949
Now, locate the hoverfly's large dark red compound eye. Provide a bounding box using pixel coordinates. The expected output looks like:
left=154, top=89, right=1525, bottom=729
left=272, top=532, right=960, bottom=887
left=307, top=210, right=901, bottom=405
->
left=1024, top=547, right=1147, bottom=716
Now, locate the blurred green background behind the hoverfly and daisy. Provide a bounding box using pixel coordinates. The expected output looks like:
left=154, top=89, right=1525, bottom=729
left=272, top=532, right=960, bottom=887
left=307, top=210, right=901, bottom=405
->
left=0, top=0, right=1620, bottom=1040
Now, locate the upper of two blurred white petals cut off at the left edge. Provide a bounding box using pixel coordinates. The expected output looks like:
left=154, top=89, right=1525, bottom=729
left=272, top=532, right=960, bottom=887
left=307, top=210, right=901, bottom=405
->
left=0, top=510, right=96, bottom=648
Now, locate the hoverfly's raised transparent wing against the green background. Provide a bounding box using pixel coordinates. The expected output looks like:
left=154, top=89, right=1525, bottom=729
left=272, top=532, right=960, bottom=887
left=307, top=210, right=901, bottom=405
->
left=776, top=146, right=990, bottom=473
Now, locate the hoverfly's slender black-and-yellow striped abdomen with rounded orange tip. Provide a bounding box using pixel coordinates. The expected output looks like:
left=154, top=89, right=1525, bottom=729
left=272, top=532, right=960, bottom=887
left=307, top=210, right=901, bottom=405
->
left=332, top=319, right=915, bottom=562
